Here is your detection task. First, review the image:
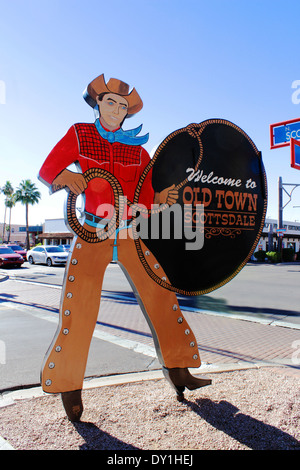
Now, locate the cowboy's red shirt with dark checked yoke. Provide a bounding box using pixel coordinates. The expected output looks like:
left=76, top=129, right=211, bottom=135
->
left=39, top=123, right=154, bottom=219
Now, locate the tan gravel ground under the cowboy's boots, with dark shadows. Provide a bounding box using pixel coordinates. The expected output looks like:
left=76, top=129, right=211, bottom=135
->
left=0, top=367, right=300, bottom=451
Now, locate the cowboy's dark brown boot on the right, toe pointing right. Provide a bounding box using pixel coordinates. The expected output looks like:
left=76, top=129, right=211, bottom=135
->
left=163, top=367, right=211, bottom=401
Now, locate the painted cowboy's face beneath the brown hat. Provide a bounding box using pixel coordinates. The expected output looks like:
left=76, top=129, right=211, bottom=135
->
left=97, top=93, right=128, bottom=131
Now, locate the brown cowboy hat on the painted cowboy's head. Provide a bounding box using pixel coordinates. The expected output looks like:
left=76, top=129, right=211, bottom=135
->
left=83, top=74, right=143, bottom=116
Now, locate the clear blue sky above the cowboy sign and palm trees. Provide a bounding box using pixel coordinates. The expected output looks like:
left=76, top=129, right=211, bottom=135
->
left=0, top=0, right=300, bottom=225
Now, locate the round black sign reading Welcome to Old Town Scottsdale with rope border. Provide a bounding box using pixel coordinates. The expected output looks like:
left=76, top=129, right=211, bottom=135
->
left=135, top=119, right=267, bottom=295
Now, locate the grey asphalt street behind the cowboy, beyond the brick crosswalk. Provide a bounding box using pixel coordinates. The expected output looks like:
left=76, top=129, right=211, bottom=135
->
left=0, top=262, right=300, bottom=317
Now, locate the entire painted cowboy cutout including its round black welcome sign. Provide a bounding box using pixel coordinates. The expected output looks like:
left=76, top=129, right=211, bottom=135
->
left=39, top=74, right=266, bottom=421
